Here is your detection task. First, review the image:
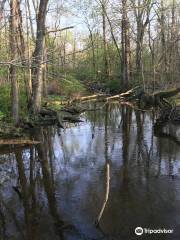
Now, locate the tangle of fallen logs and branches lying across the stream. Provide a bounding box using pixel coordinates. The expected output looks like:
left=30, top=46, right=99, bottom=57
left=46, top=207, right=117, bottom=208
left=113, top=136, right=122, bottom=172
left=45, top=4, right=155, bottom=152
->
left=40, top=86, right=180, bottom=127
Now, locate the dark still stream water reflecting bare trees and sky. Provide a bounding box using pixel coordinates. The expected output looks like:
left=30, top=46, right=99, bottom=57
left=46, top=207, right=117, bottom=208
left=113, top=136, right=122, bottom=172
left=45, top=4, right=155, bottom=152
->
left=0, top=104, right=180, bottom=240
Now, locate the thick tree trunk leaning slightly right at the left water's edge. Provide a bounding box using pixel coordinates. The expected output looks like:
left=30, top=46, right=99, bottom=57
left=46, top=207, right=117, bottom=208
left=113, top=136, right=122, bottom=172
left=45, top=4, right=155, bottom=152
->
left=32, top=0, right=48, bottom=113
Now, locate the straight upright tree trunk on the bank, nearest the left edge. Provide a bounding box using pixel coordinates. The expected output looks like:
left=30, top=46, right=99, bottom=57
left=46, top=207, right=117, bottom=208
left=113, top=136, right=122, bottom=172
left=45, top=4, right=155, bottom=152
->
left=9, top=0, right=19, bottom=124
